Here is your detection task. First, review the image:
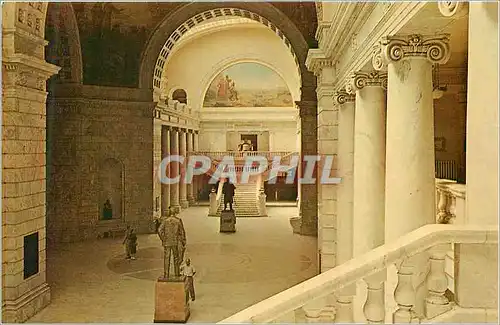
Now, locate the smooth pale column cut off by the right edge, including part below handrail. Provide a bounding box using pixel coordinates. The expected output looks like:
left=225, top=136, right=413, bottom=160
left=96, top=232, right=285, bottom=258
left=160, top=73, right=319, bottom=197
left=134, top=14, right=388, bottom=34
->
left=454, top=2, right=499, bottom=310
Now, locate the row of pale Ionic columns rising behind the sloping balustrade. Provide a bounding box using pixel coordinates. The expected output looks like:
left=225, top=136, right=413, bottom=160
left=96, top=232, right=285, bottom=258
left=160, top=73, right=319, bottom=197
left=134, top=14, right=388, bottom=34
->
left=314, top=35, right=450, bottom=274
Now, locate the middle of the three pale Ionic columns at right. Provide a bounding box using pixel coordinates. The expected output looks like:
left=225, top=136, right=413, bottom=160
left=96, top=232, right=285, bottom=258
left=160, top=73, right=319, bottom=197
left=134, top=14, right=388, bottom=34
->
left=348, top=71, right=387, bottom=256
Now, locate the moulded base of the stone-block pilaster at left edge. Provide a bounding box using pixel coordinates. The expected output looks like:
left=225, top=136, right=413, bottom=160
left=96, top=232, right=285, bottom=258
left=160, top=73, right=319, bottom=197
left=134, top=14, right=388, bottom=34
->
left=2, top=283, right=50, bottom=323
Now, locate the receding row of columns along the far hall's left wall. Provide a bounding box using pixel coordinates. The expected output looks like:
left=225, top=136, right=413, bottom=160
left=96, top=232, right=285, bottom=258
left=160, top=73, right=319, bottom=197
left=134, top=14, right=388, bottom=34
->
left=154, top=122, right=203, bottom=216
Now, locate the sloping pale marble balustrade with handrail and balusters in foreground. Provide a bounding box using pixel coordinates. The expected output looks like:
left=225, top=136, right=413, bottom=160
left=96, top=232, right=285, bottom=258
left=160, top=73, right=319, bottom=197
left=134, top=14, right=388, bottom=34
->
left=220, top=224, right=498, bottom=323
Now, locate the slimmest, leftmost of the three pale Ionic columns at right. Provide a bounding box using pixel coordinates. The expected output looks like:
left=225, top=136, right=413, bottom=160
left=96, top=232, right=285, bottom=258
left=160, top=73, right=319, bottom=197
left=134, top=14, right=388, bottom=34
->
left=335, top=91, right=355, bottom=265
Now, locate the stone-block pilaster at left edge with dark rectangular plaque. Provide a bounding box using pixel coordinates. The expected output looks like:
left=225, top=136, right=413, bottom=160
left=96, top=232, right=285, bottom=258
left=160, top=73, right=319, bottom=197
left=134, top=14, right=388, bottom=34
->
left=2, top=53, right=59, bottom=322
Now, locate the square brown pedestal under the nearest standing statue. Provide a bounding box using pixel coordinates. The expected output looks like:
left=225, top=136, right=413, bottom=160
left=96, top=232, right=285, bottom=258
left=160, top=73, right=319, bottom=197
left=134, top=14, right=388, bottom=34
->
left=154, top=278, right=190, bottom=323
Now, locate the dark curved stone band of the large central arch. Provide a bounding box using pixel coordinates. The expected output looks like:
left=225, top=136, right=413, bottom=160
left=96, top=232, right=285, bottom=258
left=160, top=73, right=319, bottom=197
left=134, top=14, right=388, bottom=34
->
left=139, top=2, right=316, bottom=102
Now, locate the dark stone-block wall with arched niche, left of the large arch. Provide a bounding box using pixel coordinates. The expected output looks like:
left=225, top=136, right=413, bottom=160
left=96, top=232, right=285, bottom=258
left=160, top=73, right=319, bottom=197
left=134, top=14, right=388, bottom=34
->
left=47, top=85, right=154, bottom=242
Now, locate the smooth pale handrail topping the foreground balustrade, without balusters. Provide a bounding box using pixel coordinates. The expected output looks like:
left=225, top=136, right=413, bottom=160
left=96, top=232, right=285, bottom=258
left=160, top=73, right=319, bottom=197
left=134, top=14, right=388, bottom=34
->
left=219, top=224, right=498, bottom=324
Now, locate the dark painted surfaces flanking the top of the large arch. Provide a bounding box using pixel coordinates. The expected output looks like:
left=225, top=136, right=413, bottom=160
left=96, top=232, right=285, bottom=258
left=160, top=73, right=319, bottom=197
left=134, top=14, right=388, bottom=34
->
left=60, top=2, right=317, bottom=87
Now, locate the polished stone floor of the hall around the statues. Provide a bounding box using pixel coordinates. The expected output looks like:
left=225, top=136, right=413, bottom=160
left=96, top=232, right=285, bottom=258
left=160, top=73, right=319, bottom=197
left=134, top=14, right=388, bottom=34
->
left=30, top=207, right=317, bottom=323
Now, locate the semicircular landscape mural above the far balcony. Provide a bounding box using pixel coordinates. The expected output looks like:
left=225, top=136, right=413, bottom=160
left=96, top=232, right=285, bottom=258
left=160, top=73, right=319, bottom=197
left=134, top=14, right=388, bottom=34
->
left=203, top=62, right=293, bottom=107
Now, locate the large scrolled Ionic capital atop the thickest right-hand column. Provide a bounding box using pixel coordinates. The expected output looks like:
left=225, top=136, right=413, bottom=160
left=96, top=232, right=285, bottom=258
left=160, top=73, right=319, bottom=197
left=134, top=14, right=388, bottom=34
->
left=372, top=34, right=451, bottom=70
